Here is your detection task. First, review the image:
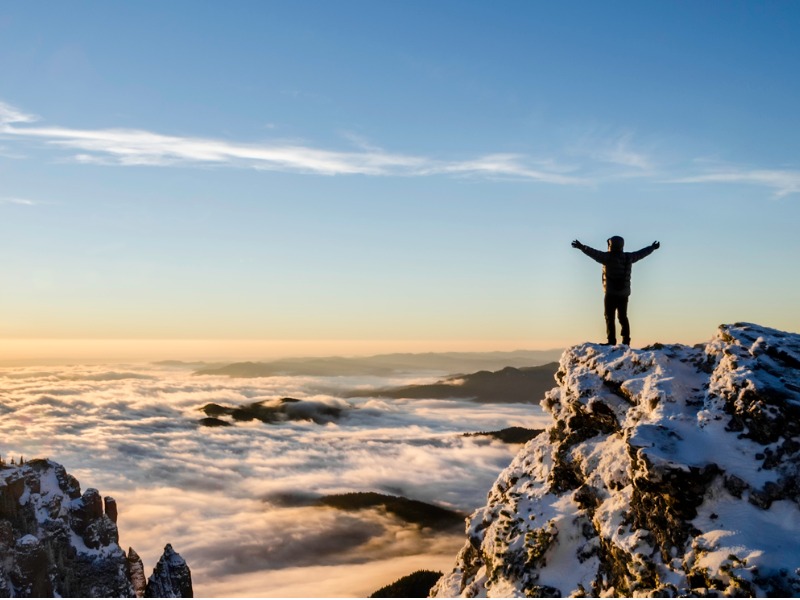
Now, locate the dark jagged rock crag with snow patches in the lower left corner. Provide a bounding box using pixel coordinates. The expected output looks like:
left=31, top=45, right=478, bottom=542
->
left=0, top=459, right=192, bottom=598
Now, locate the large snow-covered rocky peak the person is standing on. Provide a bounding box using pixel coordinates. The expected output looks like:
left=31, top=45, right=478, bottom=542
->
left=432, top=323, right=800, bottom=597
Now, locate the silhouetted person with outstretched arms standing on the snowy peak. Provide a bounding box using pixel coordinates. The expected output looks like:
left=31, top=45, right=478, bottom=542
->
left=572, top=235, right=661, bottom=346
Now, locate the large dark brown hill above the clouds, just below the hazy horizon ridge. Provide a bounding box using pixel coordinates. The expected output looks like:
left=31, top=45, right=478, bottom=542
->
left=347, top=362, right=558, bottom=404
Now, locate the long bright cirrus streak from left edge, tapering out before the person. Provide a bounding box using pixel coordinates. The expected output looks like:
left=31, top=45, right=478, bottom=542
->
left=0, top=104, right=583, bottom=185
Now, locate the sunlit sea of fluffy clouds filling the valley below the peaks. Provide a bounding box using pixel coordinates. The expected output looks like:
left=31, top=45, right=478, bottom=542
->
left=0, top=364, right=548, bottom=597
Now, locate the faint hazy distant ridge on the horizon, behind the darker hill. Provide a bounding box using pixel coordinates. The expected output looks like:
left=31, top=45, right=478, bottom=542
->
left=194, top=350, right=562, bottom=377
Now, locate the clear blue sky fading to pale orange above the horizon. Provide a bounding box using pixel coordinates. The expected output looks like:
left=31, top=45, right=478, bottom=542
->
left=0, top=1, right=800, bottom=354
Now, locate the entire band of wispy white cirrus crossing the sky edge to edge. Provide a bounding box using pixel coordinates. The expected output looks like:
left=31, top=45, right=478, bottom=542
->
left=0, top=102, right=800, bottom=196
